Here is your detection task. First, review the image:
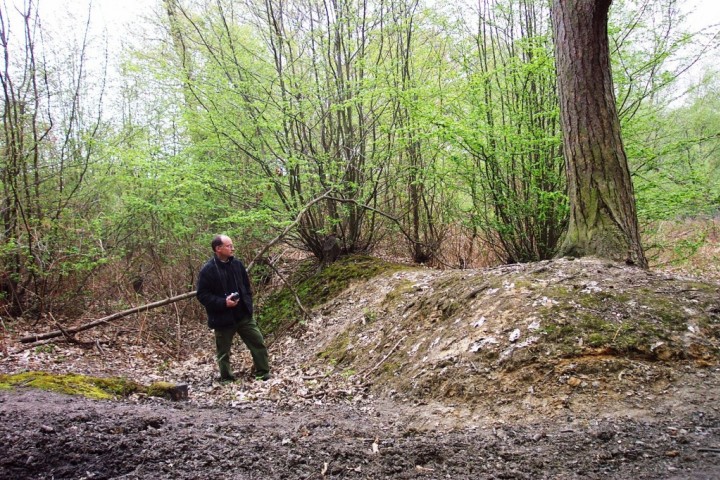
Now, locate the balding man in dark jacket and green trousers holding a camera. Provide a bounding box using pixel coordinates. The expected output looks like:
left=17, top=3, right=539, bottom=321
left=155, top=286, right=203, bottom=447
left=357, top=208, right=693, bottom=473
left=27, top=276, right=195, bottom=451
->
left=197, top=235, right=270, bottom=382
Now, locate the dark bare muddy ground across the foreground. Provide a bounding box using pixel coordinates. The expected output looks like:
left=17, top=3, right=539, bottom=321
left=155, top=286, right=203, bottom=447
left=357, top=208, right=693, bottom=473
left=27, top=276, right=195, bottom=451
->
left=0, top=389, right=720, bottom=479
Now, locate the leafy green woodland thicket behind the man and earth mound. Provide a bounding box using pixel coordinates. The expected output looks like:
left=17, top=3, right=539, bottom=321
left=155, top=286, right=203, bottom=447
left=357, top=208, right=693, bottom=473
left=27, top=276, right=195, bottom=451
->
left=0, top=0, right=720, bottom=341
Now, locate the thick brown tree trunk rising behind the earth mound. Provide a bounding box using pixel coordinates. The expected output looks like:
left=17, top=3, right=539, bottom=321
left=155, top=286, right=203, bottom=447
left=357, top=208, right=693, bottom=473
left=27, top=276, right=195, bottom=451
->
left=552, top=0, right=647, bottom=268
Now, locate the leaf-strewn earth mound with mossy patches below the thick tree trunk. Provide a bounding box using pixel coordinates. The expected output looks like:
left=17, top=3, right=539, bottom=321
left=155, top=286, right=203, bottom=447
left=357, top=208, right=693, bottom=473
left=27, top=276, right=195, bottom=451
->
left=298, top=259, right=720, bottom=422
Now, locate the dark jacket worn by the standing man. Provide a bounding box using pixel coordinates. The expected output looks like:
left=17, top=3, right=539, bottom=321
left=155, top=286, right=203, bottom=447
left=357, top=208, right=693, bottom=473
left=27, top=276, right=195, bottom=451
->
left=197, top=256, right=253, bottom=329
